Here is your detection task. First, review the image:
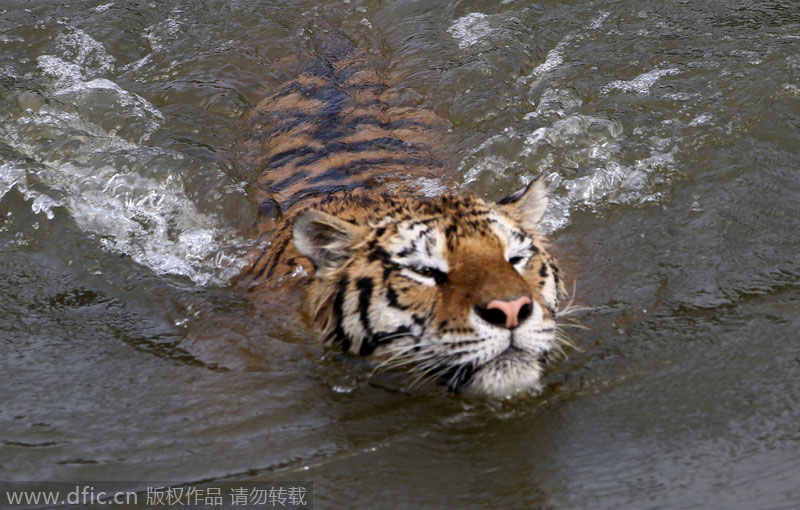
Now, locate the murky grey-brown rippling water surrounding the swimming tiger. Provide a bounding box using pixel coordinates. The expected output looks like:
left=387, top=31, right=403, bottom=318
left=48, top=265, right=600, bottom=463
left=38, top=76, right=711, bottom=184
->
left=0, top=0, right=800, bottom=508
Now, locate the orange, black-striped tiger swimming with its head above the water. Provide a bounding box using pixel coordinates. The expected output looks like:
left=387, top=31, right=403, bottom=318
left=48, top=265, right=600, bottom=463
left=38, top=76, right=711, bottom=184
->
left=235, top=32, right=565, bottom=399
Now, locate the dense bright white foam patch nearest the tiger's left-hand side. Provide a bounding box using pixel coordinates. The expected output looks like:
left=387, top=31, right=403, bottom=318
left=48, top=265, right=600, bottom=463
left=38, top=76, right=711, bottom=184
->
left=66, top=164, right=250, bottom=285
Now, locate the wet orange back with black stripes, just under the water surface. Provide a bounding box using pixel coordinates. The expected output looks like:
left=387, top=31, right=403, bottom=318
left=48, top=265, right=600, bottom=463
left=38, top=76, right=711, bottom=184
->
left=239, top=49, right=450, bottom=223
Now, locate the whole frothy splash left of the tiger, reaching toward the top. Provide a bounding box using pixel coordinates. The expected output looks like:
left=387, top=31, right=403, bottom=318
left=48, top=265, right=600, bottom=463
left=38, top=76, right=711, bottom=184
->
left=0, top=29, right=246, bottom=285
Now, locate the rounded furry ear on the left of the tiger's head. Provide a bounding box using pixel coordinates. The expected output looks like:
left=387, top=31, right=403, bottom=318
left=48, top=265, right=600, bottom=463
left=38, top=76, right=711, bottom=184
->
left=293, top=209, right=361, bottom=272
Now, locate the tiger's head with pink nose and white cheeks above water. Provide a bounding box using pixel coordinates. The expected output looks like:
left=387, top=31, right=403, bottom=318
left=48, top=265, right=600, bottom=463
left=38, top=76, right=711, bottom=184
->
left=294, top=179, right=564, bottom=398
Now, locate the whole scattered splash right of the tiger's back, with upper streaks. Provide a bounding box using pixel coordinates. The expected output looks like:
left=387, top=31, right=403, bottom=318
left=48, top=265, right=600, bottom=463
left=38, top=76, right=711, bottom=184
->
left=458, top=12, right=684, bottom=233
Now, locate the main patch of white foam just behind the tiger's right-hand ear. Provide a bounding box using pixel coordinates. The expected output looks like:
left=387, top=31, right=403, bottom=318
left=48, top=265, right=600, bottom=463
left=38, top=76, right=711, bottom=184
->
left=459, top=104, right=679, bottom=233
